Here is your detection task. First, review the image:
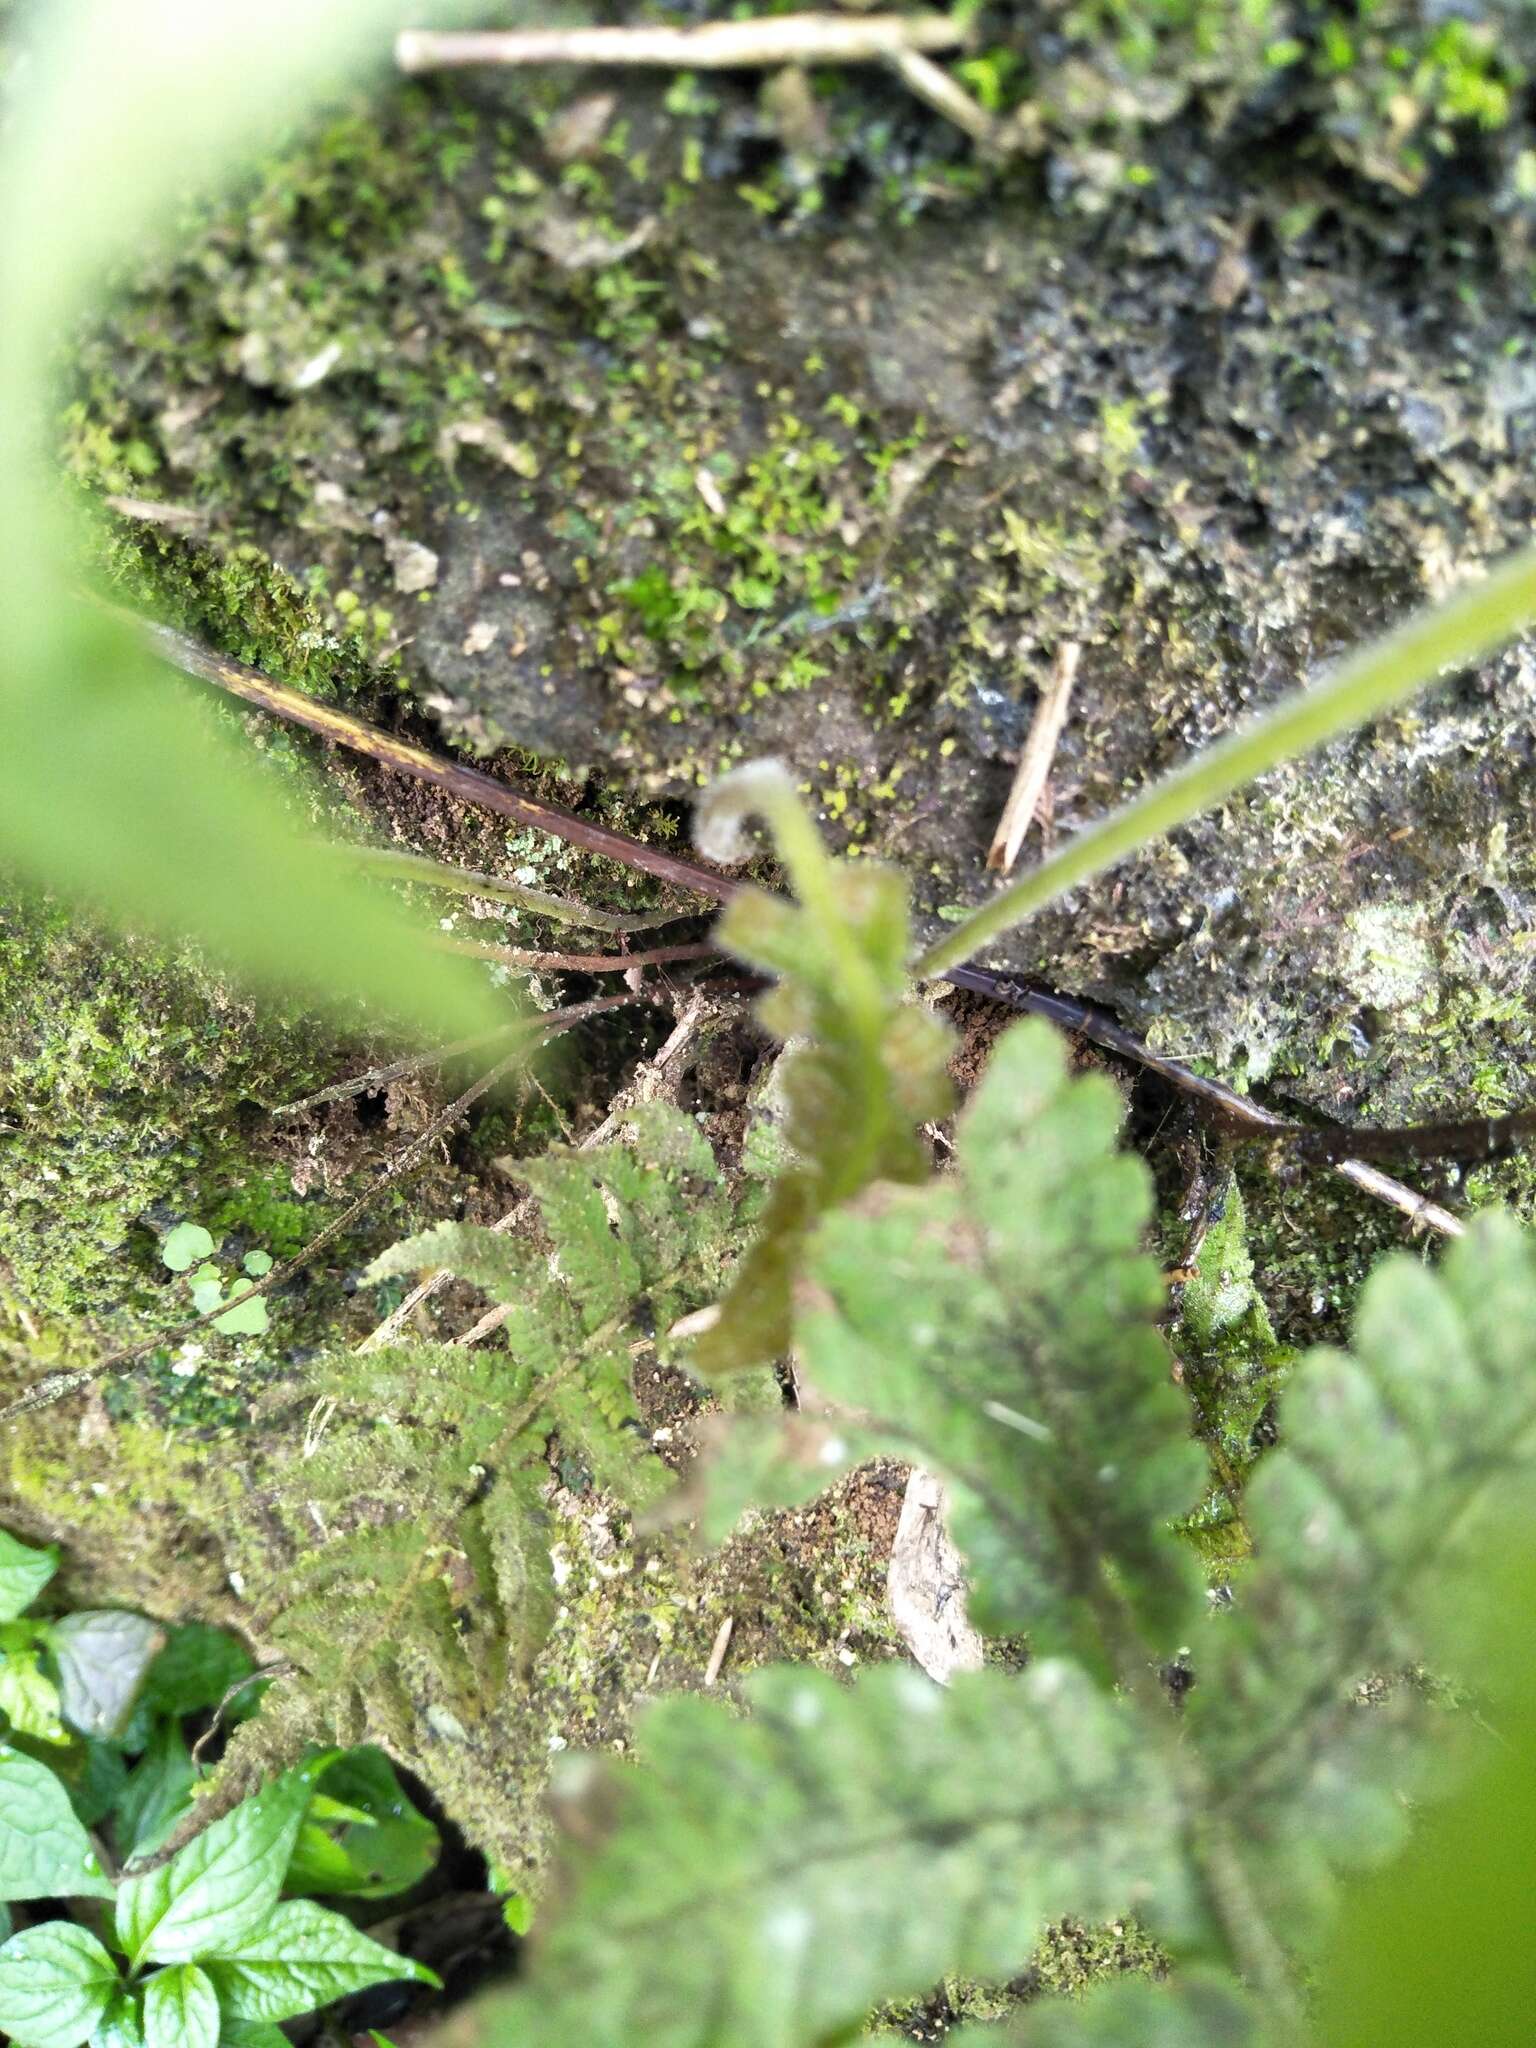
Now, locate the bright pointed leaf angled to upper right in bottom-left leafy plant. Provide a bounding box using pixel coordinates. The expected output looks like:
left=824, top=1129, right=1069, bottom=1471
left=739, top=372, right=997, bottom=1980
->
left=117, top=1763, right=319, bottom=1968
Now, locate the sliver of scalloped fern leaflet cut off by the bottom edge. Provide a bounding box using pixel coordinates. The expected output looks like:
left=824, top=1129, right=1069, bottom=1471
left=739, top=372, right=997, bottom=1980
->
left=946, top=1970, right=1278, bottom=2048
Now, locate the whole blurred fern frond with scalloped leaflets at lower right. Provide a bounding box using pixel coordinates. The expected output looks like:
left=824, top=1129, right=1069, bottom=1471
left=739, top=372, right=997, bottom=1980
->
left=479, top=1024, right=1536, bottom=2048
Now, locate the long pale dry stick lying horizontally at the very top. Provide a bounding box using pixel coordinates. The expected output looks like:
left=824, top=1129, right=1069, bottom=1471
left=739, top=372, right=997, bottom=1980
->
left=395, top=14, right=963, bottom=72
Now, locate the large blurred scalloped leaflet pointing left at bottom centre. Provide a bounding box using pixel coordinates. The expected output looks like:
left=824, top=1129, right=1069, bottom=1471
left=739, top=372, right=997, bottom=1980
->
left=487, top=1661, right=1182, bottom=2048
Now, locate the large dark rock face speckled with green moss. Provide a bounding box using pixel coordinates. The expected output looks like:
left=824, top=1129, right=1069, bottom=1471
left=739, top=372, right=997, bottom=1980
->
left=75, top=24, right=1536, bottom=1163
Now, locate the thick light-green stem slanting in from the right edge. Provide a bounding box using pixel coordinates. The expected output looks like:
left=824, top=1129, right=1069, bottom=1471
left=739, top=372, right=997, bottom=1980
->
left=913, top=547, right=1536, bottom=981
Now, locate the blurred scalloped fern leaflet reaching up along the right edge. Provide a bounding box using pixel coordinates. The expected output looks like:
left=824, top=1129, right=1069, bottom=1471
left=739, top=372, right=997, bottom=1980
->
left=1188, top=1217, right=1536, bottom=1937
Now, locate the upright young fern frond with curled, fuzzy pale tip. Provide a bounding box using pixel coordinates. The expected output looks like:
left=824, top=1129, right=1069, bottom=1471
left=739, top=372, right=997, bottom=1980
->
left=698, top=762, right=948, bottom=1374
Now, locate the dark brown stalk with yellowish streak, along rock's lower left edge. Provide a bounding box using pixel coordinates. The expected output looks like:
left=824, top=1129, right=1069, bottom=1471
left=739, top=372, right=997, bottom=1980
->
left=139, top=621, right=737, bottom=903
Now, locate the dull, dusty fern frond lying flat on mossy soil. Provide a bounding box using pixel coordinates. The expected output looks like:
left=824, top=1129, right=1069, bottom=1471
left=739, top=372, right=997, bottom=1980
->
left=257, top=1106, right=733, bottom=1716
